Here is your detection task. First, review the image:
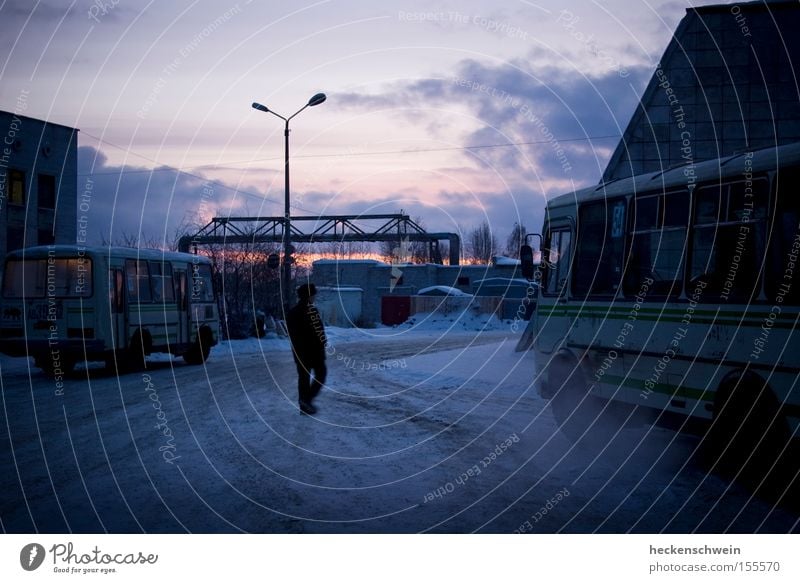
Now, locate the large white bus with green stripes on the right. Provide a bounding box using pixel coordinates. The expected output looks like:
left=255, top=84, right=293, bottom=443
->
left=525, top=143, right=800, bottom=484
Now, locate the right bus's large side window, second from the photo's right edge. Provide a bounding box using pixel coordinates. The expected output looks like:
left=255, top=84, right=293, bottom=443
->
left=687, top=178, right=769, bottom=301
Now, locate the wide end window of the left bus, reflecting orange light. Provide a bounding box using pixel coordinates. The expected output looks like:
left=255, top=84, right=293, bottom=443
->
left=3, top=257, right=92, bottom=299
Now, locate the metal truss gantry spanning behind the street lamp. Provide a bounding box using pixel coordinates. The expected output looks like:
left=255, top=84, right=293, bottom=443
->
left=178, top=214, right=461, bottom=265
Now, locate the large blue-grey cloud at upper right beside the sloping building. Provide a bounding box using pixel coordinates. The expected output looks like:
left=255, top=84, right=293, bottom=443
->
left=338, top=49, right=651, bottom=192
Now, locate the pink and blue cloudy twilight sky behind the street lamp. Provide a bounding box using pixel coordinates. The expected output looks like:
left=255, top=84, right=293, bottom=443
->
left=0, top=0, right=719, bottom=245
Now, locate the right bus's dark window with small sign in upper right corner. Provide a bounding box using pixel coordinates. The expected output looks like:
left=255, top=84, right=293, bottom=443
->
left=572, top=198, right=626, bottom=296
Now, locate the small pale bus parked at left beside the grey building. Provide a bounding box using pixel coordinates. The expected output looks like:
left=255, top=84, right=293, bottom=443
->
left=0, top=245, right=219, bottom=375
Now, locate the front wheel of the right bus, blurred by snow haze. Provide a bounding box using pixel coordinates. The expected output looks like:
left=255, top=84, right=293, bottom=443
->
left=550, top=360, right=623, bottom=451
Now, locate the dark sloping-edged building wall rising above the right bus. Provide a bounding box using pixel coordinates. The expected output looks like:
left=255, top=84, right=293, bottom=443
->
left=603, top=1, right=800, bottom=182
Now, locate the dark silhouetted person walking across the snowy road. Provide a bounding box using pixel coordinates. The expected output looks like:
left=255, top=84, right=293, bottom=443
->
left=286, top=283, right=328, bottom=415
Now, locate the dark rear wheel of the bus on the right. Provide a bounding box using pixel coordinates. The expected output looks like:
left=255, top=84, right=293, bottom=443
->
left=701, top=375, right=798, bottom=494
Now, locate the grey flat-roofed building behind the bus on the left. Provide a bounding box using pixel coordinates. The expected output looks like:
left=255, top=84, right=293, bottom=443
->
left=0, top=111, right=78, bottom=262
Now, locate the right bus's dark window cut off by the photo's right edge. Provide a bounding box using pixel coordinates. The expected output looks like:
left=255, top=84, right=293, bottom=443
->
left=765, top=170, right=800, bottom=305
